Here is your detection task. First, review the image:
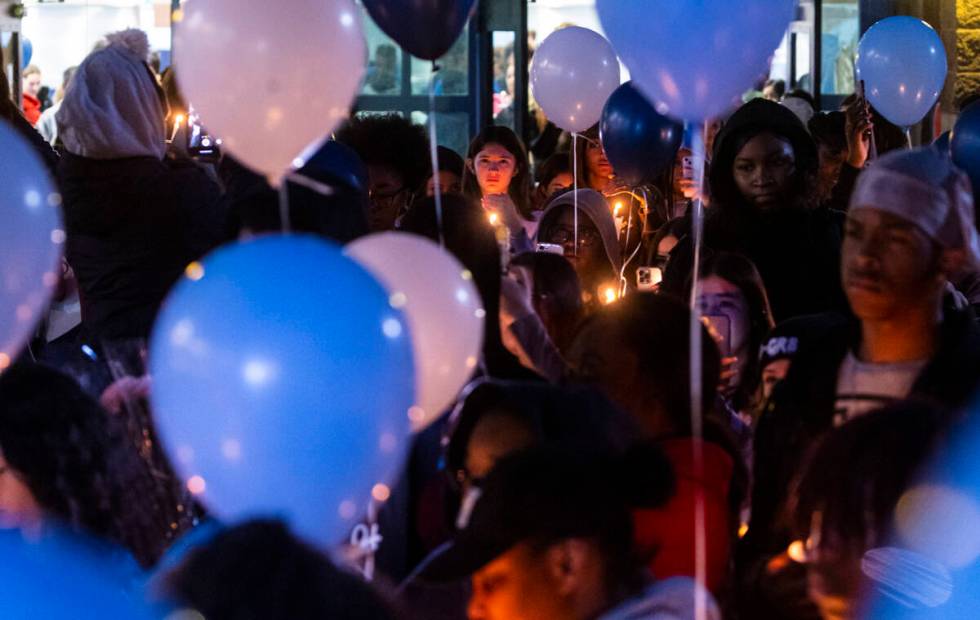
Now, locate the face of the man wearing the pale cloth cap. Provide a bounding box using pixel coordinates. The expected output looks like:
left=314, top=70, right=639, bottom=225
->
left=841, top=208, right=944, bottom=320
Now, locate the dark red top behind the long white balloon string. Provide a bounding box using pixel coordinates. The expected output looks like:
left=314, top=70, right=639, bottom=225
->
left=633, top=438, right=734, bottom=592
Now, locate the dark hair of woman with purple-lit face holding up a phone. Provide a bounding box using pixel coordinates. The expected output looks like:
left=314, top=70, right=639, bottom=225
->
left=701, top=252, right=775, bottom=410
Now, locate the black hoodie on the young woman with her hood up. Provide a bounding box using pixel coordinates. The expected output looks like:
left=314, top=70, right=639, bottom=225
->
left=668, top=99, right=847, bottom=323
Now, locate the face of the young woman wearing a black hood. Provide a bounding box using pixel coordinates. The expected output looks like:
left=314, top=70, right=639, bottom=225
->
left=732, top=132, right=796, bottom=208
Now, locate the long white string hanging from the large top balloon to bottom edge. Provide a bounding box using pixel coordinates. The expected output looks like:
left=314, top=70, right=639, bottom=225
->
left=687, top=123, right=707, bottom=620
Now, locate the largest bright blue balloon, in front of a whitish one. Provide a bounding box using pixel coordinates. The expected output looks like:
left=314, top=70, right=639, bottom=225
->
left=150, top=235, right=415, bottom=546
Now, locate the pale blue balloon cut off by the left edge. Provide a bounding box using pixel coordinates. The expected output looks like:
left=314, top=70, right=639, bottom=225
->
left=0, top=123, right=65, bottom=371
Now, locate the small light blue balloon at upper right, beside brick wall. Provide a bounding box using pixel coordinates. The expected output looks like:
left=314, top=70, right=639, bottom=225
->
left=856, top=15, right=947, bottom=127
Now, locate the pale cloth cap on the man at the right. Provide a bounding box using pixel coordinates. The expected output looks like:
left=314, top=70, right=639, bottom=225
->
left=850, top=148, right=980, bottom=265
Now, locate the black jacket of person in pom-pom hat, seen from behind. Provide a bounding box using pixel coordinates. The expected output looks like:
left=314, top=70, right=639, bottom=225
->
left=58, top=154, right=224, bottom=342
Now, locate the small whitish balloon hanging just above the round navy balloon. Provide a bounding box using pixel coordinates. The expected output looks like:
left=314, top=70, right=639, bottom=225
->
left=531, top=27, right=620, bottom=132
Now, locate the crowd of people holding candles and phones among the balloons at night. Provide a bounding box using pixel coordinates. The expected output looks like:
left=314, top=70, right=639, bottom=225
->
left=0, top=25, right=980, bottom=620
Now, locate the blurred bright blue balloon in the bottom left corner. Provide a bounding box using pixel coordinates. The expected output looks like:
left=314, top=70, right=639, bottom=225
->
left=0, top=527, right=156, bottom=620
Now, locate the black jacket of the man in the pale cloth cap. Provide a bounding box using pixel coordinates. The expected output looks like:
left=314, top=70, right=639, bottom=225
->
left=742, top=308, right=980, bottom=560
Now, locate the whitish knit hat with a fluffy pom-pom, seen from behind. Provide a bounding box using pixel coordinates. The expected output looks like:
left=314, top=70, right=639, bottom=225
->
left=57, top=29, right=166, bottom=159
